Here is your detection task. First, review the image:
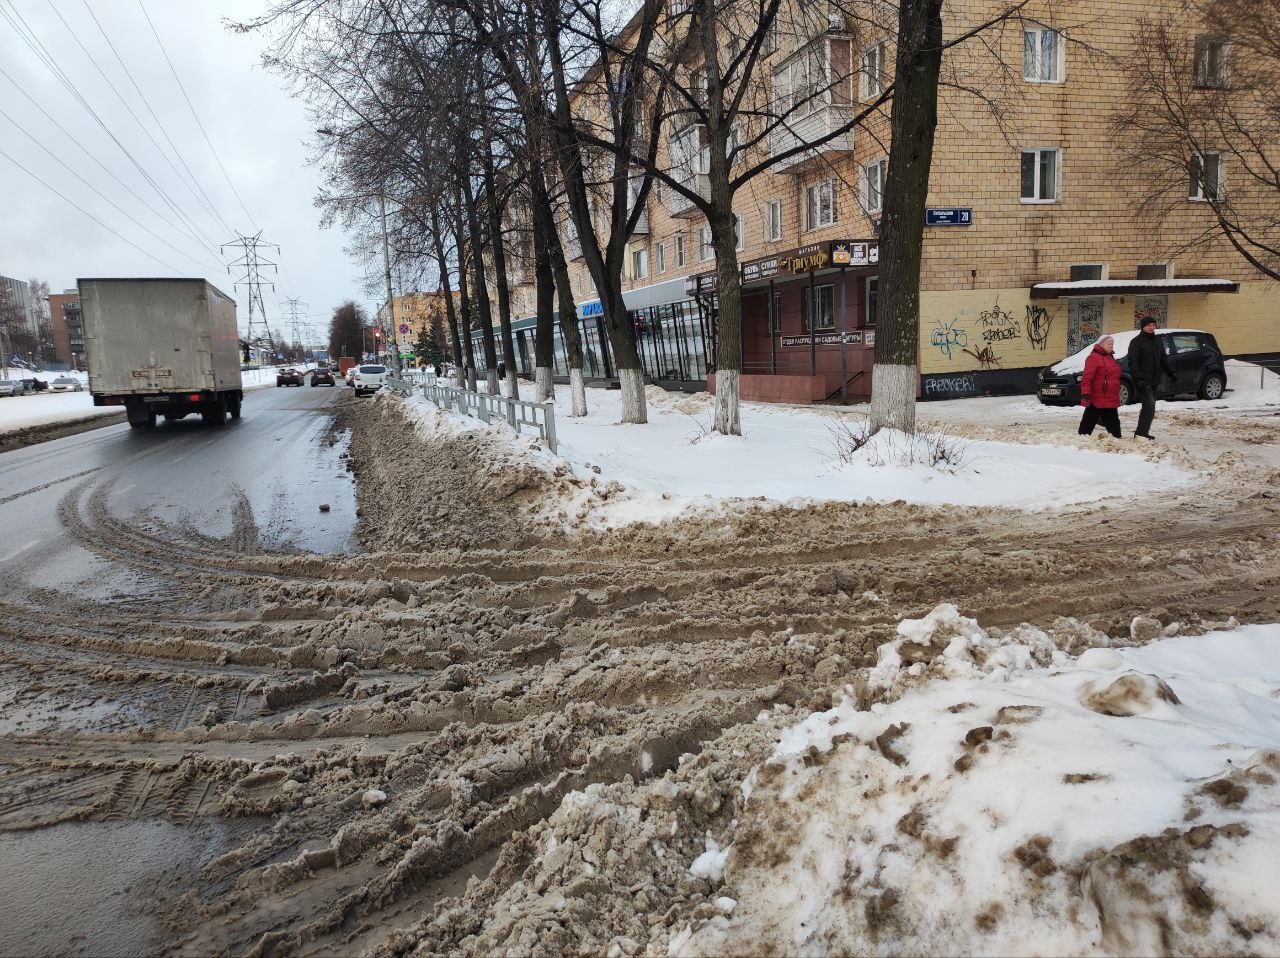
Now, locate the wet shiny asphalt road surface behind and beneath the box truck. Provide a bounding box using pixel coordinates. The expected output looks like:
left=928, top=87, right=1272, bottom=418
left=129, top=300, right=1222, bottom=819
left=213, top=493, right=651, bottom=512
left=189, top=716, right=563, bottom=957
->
left=0, top=386, right=356, bottom=598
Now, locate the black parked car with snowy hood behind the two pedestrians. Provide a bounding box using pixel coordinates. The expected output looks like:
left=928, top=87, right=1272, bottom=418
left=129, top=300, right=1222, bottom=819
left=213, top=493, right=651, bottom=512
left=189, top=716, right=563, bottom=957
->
left=1036, top=329, right=1226, bottom=406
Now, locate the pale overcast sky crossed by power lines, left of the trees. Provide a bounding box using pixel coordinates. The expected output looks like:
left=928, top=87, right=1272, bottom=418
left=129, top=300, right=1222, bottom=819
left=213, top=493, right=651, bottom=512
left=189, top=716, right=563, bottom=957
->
left=0, top=0, right=374, bottom=336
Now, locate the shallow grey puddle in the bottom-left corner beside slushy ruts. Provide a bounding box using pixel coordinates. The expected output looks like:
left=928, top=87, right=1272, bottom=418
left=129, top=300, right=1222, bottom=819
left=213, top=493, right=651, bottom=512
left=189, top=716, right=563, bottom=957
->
left=0, top=821, right=229, bottom=958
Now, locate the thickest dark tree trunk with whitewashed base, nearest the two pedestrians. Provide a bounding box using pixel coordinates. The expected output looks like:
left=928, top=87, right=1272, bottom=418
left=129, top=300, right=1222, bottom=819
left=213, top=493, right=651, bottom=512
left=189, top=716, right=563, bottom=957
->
left=870, top=0, right=942, bottom=433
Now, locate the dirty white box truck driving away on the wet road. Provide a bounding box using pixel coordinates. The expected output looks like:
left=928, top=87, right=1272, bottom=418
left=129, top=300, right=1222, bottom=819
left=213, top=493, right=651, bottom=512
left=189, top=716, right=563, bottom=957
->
left=78, top=279, right=244, bottom=429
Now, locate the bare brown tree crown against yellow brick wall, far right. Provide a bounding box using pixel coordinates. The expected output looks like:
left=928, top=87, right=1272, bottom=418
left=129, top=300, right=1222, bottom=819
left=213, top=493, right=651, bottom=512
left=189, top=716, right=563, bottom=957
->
left=1115, top=0, right=1280, bottom=279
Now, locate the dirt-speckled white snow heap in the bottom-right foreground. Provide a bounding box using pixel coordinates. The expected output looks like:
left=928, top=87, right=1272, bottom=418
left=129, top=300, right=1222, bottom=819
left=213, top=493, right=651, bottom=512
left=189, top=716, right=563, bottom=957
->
left=672, top=606, right=1280, bottom=954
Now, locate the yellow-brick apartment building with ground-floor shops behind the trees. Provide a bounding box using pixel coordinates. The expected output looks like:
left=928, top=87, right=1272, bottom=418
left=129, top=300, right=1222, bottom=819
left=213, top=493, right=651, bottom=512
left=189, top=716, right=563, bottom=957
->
left=483, top=0, right=1280, bottom=402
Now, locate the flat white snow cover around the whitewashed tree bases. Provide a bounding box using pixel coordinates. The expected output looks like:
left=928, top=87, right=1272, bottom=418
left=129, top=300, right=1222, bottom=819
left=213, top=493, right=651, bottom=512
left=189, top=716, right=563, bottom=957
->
left=412, top=387, right=1194, bottom=526
